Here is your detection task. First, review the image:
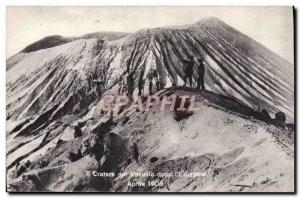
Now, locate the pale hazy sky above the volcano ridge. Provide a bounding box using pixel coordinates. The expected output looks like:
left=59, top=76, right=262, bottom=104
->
left=6, top=7, right=293, bottom=63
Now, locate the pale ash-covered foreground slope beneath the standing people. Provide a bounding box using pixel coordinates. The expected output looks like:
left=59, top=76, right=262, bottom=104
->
left=7, top=88, right=294, bottom=192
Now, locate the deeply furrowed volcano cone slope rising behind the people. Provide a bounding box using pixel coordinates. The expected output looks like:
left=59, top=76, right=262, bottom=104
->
left=7, top=18, right=294, bottom=129
